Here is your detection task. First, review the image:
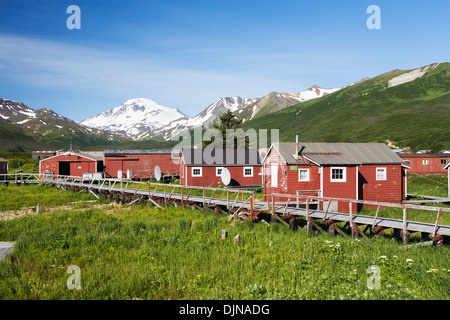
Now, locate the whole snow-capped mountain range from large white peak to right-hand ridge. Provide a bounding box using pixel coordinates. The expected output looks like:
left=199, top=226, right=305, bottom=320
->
left=80, top=85, right=339, bottom=140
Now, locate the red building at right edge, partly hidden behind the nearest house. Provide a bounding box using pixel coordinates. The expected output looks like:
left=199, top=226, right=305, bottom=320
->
left=399, top=153, right=450, bottom=174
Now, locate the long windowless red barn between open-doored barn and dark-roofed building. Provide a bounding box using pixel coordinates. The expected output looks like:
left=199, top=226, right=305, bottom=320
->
left=105, top=150, right=180, bottom=179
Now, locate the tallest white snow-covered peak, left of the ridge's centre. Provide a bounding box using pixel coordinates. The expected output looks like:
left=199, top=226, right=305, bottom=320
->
left=80, top=98, right=188, bottom=139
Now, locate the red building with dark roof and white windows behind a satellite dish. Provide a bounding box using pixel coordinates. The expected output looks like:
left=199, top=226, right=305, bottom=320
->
left=180, top=148, right=262, bottom=187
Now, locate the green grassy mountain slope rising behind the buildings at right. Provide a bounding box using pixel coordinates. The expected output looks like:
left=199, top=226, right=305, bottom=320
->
left=243, top=63, right=450, bottom=150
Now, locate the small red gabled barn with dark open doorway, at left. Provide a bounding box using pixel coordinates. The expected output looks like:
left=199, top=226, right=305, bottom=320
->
left=39, top=151, right=103, bottom=177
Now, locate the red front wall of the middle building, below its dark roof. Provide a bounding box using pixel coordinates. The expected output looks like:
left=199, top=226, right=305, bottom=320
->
left=180, top=164, right=262, bottom=187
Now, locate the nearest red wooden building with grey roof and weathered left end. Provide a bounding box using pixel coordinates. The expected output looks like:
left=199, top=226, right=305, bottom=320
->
left=263, top=142, right=406, bottom=212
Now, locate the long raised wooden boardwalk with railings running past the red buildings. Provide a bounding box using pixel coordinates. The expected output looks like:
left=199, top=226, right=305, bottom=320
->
left=0, top=174, right=450, bottom=243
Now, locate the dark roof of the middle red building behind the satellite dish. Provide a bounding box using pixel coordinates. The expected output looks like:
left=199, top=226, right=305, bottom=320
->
left=181, top=148, right=261, bottom=166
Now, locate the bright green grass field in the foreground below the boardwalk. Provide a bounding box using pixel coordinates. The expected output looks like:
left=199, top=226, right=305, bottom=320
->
left=0, top=185, right=450, bottom=300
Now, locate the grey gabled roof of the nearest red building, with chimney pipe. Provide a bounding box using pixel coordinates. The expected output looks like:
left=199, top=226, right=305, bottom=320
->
left=268, top=142, right=402, bottom=165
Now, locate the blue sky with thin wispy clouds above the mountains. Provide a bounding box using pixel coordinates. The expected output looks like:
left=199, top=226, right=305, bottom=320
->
left=0, top=0, right=450, bottom=121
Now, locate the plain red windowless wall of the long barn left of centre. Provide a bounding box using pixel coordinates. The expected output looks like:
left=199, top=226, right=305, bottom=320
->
left=105, top=154, right=180, bottom=178
